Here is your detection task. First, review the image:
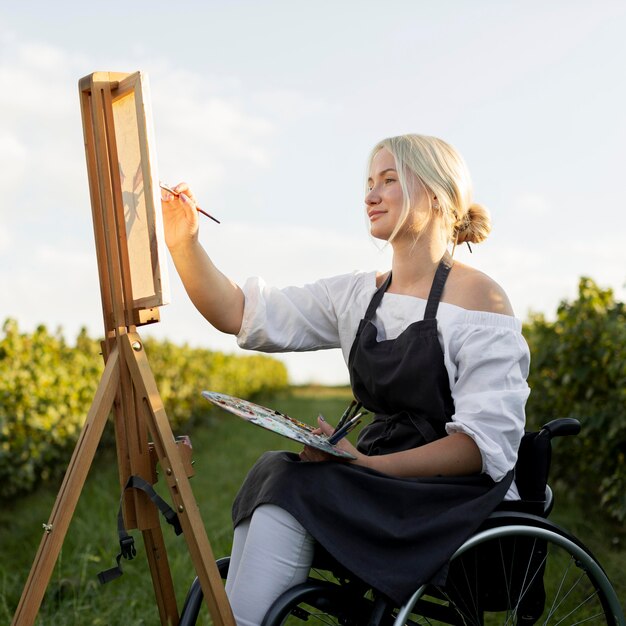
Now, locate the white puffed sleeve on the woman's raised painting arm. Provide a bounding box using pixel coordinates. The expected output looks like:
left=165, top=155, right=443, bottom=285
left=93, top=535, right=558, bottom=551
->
left=237, top=273, right=357, bottom=352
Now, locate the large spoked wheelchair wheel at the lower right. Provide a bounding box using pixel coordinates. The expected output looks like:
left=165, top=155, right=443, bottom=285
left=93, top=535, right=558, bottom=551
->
left=394, top=516, right=626, bottom=626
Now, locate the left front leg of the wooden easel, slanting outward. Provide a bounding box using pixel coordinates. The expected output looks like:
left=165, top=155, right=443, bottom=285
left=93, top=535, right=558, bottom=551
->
left=12, top=350, right=119, bottom=626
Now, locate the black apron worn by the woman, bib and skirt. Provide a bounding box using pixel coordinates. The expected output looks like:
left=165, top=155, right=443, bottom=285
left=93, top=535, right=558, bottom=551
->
left=233, top=255, right=513, bottom=604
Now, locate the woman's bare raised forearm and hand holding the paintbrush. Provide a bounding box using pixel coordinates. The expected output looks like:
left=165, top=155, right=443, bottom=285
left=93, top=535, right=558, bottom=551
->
left=162, top=183, right=244, bottom=335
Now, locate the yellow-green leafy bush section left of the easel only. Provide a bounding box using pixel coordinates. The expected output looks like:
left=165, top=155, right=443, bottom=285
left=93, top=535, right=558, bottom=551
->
left=0, top=320, right=103, bottom=497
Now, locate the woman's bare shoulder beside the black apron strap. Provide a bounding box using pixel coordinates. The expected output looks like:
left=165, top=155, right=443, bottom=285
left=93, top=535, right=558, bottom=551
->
left=443, top=263, right=514, bottom=315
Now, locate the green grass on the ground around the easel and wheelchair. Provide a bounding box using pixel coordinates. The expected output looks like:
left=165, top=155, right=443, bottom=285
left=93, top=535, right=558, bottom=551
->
left=0, top=388, right=626, bottom=626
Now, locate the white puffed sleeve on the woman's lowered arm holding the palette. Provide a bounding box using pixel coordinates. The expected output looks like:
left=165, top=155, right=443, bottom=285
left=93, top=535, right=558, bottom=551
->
left=446, top=311, right=530, bottom=481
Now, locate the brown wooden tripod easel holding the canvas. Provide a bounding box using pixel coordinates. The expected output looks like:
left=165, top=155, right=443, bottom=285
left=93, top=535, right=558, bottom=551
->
left=12, top=72, right=235, bottom=626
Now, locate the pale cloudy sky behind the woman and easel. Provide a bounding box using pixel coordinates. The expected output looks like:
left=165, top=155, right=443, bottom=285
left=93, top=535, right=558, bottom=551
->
left=0, top=0, right=626, bottom=382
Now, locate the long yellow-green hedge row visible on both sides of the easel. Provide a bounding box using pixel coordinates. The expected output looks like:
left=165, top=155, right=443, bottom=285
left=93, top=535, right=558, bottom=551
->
left=0, top=319, right=288, bottom=499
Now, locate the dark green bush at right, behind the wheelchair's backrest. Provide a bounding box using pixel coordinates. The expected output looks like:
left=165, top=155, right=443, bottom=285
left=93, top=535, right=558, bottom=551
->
left=524, top=278, right=626, bottom=521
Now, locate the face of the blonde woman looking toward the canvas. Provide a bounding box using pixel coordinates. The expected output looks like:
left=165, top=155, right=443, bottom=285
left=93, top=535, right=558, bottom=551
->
left=365, top=148, right=424, bottom=241
